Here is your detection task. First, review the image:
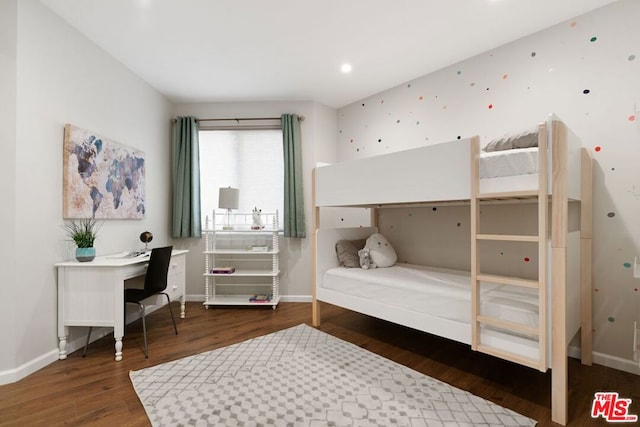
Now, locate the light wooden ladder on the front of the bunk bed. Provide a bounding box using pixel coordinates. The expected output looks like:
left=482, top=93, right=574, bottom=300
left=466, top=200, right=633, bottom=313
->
left=471, top=123, right=548, bottom=372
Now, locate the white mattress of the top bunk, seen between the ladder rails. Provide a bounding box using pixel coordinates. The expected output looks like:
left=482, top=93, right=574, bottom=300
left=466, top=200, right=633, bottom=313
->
left=480, top=147, right=538, bottom=179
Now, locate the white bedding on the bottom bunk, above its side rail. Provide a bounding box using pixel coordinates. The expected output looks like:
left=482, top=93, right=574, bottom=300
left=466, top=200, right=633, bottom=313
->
left=322, top=264, right=538, bottom=338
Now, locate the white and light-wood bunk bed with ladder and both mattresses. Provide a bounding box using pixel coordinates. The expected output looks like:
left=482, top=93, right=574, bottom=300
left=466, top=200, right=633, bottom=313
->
left=312, top=115, right=592, bottom=425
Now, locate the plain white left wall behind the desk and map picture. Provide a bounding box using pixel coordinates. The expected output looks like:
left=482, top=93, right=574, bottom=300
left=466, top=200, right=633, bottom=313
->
left=0, top=0, right=171, bottom=383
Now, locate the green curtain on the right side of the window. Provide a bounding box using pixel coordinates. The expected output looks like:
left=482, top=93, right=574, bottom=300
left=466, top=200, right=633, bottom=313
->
left=281, top=114, right=306, bottom=237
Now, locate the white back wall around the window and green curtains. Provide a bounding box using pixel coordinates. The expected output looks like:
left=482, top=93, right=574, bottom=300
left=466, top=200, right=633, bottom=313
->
left=173, top=102, right=337, bottom=301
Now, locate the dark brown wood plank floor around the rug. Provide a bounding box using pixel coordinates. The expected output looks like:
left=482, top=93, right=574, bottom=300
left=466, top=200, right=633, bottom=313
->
left=0, top=303, right=640, bottom=427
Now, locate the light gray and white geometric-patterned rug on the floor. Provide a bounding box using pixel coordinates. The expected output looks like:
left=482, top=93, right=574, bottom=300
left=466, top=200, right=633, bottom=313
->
left=130, top=325, right=536, bottom=427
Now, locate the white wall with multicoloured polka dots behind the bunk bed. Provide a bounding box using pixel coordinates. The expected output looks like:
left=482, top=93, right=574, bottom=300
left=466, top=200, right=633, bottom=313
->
left=338, top=0, right=640, bottom=372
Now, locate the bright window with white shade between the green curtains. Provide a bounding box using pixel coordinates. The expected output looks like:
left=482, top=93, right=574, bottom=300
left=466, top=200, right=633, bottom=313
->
left=199, top=129, right=284, bottom=228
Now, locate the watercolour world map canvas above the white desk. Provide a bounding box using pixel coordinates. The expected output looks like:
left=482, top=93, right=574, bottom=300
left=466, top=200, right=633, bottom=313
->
left=63, top=124, right=145, bottom=219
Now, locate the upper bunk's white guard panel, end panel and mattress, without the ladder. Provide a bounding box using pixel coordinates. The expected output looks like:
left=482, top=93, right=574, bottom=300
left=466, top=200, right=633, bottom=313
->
left=315, top=116, right=582, bottom=207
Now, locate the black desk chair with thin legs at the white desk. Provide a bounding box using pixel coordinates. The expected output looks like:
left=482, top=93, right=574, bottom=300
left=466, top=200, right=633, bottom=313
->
left=82, top=246, right=178, bottom=359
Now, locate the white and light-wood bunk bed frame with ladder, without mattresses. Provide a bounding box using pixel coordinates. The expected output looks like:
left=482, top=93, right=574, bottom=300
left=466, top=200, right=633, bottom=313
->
left=312, top=115, right=592, bottom=425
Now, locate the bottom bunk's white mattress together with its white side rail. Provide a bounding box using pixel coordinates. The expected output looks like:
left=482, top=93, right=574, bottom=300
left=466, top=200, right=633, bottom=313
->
left=318, top=264, right=538, bottom=358
